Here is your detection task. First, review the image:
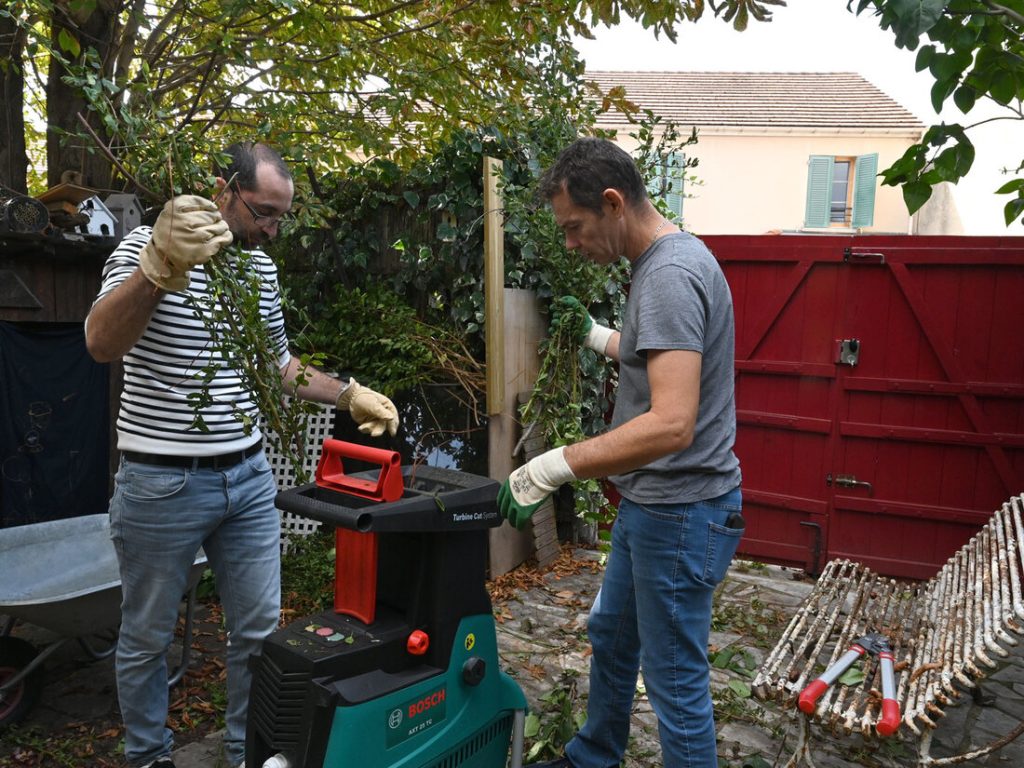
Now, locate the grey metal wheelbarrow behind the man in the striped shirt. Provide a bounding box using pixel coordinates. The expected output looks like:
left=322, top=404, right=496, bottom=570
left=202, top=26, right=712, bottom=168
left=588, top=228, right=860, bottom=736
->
left=0, top=514, right=206, bottom=728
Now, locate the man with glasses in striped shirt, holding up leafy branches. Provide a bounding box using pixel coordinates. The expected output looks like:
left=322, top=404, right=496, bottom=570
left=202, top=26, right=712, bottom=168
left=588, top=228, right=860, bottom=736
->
left=85, top=142, right=398, bottom=768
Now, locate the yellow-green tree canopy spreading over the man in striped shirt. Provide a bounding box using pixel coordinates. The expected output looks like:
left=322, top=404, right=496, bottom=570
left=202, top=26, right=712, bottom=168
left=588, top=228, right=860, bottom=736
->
left=0, top=0, right=781, bottom=196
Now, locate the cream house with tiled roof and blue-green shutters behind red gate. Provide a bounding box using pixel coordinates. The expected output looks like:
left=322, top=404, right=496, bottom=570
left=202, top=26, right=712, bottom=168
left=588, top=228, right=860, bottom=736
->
left=587, top=71, right=961, bottom=234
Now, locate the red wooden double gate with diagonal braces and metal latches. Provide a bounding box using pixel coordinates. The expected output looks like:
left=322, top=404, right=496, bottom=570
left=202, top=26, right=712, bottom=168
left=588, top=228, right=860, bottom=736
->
left=703, top=236, right=1024, bottom=579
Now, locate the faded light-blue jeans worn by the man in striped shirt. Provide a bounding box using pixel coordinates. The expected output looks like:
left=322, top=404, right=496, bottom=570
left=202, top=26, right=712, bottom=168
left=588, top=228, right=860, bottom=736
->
left=111, top=452, right=281, bottom=765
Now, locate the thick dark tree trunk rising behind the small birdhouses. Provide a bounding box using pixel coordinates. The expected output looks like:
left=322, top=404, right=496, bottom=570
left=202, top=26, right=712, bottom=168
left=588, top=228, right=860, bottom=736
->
left=46, top=2, right=120, bottom=189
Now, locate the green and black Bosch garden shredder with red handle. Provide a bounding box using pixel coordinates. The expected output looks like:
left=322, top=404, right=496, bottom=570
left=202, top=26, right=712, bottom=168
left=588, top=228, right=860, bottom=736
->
left=246, top=439, right=526, bottom=768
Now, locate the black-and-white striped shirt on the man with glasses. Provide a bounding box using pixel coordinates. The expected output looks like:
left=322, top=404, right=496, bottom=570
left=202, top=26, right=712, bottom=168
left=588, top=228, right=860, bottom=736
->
left=96, top=226, right=291, bottom=456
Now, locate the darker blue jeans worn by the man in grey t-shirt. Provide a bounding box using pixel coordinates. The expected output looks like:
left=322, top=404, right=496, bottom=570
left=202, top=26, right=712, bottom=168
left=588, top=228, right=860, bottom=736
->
left=565, top=487, right=743, bottom=768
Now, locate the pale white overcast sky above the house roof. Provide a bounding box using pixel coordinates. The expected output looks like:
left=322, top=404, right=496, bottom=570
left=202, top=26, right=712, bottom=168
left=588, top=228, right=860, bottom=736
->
left=577, top=0, right=1024, bottom=236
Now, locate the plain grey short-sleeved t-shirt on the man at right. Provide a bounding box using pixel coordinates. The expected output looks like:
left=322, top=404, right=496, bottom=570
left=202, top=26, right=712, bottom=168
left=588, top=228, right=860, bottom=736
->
left=609, top=232, right=740, bottom=504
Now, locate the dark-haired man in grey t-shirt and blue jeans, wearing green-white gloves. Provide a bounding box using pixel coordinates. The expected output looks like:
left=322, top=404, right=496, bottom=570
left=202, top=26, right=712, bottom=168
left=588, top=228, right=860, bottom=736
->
left=498, top=138, right=743, bottom=768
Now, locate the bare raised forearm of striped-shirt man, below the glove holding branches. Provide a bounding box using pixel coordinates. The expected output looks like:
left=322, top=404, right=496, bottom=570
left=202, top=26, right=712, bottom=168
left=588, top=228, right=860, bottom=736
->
left=85, top=269, right=164, bottom=362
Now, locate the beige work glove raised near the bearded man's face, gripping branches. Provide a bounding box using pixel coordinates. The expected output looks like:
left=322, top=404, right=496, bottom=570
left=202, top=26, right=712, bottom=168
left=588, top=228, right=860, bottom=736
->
left=138, top=195, right=232, bottom=293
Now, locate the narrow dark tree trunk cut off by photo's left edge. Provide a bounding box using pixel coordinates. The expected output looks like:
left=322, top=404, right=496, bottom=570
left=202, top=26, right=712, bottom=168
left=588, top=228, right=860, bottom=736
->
left=0, top=16, right=29, bottom=195
